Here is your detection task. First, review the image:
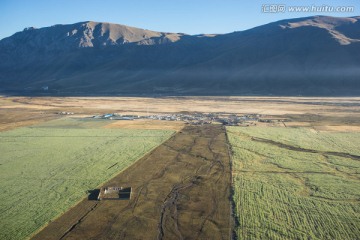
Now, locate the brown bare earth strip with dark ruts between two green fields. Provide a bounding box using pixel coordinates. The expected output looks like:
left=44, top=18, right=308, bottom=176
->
left=33, top=125, right=231, bottom=240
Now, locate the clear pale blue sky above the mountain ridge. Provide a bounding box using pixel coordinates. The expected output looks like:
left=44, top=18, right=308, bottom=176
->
left=0, top=0, right=360, bottom=39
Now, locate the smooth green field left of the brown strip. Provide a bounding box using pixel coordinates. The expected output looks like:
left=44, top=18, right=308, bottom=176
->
left=0, top=118, right=173, bottom=239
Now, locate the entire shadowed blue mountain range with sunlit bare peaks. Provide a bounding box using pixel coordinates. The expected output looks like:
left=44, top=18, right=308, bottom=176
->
left=0, top=16, right=360, bottom=96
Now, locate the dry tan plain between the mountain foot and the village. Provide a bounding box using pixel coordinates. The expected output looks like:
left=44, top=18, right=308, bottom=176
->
left=0, top=97, right=360, bottom=131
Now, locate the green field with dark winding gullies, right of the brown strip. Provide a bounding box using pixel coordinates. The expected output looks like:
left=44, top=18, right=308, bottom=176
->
left=227, top=127, right=360, bottom=240
